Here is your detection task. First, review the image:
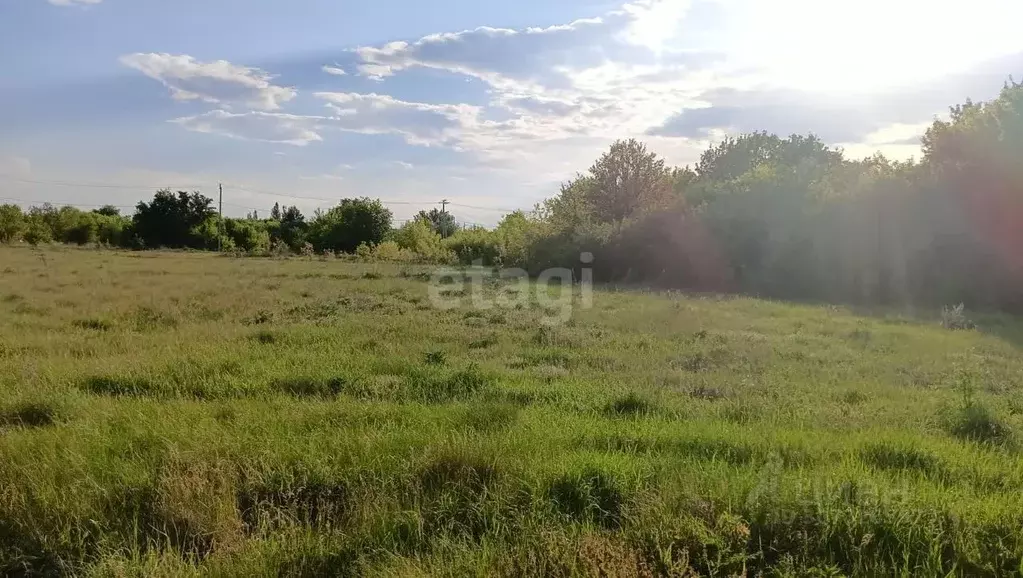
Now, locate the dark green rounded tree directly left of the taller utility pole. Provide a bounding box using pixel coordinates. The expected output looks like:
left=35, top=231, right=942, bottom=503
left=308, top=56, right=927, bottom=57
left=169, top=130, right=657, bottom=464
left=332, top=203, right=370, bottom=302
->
left=132, top=189, right=216, bottom=248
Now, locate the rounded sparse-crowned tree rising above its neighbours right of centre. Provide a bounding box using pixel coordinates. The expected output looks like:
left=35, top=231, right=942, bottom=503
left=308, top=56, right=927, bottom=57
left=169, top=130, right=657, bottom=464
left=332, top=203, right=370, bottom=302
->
left=586, top=139, right=670, bottom=224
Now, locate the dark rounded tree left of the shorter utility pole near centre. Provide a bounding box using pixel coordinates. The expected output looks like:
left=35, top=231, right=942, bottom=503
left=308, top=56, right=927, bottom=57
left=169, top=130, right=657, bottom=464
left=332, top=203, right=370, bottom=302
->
left=309, top=197, right=392, bottom=253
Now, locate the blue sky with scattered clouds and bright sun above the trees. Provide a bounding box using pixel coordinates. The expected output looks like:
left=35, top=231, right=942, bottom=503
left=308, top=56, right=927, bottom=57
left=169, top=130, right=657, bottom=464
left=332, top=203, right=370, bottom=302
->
left=0, top=0, right=1023, bottom=225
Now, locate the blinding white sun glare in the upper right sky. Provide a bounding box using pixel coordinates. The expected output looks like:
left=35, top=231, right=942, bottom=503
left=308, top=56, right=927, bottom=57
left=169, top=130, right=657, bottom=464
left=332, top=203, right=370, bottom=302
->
left=729, top=0, right=1023, bottom=91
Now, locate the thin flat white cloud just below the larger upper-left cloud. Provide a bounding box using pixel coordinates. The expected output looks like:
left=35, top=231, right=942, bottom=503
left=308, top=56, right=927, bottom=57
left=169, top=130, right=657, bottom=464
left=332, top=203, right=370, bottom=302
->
left=171, top=110, right=330, bottom=146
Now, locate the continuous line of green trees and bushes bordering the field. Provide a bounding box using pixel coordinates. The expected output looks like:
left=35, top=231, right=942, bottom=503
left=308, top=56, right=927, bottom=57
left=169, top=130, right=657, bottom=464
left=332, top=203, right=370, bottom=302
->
left=0, top=81, right=1023, bottom=312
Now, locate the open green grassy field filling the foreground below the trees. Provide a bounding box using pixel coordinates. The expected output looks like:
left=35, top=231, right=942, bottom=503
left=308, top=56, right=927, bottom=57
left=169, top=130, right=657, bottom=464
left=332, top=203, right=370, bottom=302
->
left=0, top=248, right=1023, bottom=576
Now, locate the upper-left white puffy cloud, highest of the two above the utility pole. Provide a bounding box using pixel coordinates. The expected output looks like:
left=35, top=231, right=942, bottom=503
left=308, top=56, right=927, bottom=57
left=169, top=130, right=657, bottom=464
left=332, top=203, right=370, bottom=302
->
left=121, top=52, right=298, bottom=110
